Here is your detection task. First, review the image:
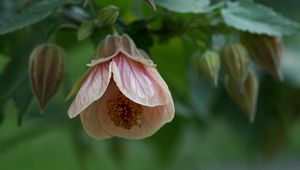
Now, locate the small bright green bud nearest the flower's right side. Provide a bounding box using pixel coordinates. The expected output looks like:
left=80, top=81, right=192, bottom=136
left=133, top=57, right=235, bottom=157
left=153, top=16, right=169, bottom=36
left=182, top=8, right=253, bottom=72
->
left=193, top=51, right=221, bottom=87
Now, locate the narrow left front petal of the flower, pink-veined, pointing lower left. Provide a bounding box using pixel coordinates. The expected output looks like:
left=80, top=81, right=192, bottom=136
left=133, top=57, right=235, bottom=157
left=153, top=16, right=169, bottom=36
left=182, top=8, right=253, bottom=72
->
left=68, top=62, right=111, bottom=118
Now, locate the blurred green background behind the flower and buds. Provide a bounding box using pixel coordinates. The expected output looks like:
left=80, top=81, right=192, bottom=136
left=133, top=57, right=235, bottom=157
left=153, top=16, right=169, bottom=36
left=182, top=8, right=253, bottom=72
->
left=0, top=0, right=300, bottom=170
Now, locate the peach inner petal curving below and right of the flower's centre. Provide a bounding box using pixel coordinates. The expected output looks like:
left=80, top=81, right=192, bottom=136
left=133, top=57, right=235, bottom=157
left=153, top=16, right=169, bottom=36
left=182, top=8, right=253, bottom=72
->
left=97, top=82, right=175, bottom=139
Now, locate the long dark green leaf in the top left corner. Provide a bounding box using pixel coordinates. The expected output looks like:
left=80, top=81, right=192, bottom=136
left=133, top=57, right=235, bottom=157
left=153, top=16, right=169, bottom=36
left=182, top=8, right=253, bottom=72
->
left=0, top=0, right=81, bottom=35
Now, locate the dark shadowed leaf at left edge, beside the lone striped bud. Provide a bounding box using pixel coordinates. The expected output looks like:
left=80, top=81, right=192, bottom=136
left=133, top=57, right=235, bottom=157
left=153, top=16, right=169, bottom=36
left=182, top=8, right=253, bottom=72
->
left=0, top=24, right=51, bottom=125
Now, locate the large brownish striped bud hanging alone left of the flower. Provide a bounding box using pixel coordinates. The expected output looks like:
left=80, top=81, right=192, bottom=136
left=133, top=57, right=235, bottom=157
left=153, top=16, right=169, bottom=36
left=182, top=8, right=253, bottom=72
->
left=29, top=43, right=65, bottom=112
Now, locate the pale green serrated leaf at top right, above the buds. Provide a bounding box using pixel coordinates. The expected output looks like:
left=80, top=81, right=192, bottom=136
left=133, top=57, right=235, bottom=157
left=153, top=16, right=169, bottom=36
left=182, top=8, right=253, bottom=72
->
left=221, top=2, right=299, bottom=36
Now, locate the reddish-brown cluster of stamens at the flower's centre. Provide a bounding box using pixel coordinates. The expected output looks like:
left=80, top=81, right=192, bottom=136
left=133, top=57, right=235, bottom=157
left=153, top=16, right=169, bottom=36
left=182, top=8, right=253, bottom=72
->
left=107, top=94, right=142, bottom=129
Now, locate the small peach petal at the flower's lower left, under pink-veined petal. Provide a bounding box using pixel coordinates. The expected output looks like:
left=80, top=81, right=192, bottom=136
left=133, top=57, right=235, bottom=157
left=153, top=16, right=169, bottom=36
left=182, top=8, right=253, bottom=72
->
left=80, top=102, right=111, bottom=140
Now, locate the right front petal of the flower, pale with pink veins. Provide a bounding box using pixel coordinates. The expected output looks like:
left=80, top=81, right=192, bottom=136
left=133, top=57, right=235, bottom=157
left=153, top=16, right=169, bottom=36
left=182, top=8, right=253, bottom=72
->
left=112, top=53, right=169, bottom=107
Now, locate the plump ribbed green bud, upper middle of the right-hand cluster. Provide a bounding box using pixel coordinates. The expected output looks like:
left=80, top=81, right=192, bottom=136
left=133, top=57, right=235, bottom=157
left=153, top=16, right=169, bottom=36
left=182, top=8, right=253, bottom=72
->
left=220, top=43, right=249, bottom=86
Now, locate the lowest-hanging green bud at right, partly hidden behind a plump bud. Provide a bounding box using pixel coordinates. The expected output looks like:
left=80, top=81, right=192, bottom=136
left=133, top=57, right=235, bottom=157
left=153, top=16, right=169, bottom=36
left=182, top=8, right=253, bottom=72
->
left=225, top=69, right=259, bottom=123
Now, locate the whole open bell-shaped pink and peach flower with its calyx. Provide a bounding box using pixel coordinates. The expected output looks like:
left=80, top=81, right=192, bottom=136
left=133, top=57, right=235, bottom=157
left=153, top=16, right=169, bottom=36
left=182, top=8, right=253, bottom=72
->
left=68, top=35, right=175, bottom=139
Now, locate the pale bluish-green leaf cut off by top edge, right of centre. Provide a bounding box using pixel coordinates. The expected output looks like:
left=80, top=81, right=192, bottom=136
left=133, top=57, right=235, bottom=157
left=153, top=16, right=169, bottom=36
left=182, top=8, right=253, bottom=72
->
left=156, top=0, right=210, bottom=13
